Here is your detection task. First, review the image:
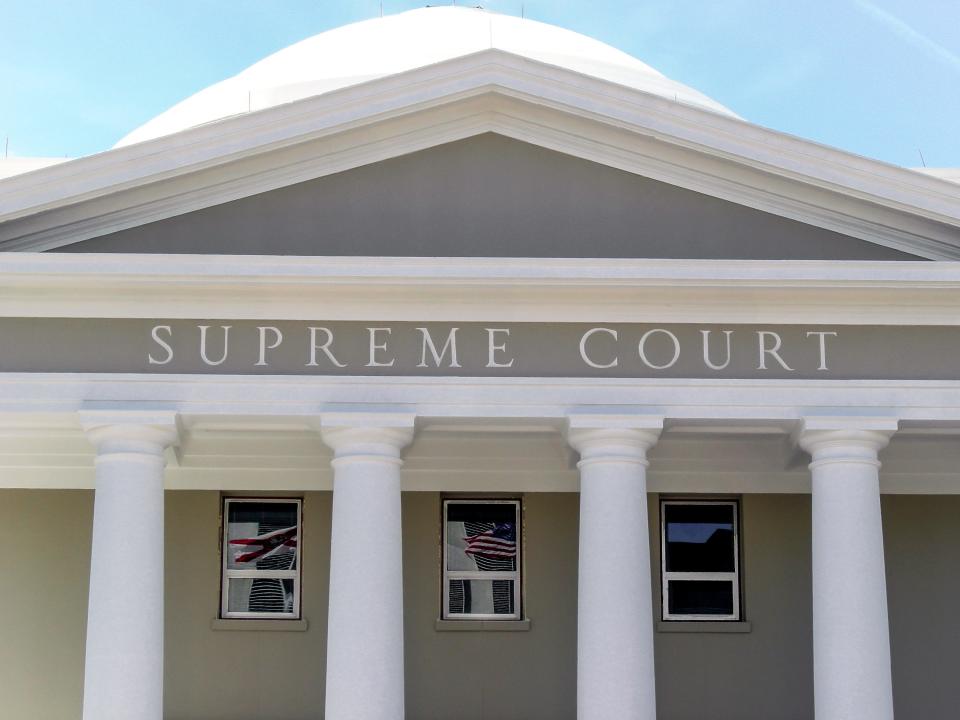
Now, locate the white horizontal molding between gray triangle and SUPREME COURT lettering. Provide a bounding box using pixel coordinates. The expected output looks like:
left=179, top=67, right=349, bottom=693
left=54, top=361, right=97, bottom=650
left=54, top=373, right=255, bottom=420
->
left=7, top=253, right=960, bottom=325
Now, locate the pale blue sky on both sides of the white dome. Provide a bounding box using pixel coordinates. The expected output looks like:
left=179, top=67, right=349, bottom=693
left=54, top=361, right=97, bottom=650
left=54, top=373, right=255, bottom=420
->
left=0, top=0, right=960, bottom=167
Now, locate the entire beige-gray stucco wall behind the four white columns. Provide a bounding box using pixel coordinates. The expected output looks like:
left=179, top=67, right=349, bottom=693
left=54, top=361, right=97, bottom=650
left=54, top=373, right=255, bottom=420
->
left=0, top=490, right=960, bottom=720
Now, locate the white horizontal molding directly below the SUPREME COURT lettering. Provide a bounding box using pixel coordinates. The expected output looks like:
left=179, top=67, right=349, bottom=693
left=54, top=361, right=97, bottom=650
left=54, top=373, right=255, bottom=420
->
left=0, top=373, right=960, bottom=420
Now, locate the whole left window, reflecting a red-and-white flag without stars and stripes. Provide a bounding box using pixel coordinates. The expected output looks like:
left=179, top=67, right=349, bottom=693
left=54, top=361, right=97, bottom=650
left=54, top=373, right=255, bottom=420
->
left=220, top=498, right=301, bottom=619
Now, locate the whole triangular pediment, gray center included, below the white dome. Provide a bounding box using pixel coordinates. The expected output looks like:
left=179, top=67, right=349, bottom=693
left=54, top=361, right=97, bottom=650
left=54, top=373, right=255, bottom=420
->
left=0, top=50, right=960, bottom=259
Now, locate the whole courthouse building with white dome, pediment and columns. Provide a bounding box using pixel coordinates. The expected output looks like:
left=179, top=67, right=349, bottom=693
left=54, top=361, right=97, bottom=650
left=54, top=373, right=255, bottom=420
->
left=0, top=7, right=960, bottom=720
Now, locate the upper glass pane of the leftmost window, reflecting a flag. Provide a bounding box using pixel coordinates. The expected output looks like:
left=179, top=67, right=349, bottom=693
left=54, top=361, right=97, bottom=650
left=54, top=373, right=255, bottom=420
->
left=227, top=502, right=297, bottom=570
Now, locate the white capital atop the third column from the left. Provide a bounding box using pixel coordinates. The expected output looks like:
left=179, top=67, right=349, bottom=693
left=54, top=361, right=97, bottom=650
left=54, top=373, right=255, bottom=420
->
left=566, top=415, right=663, bottom=467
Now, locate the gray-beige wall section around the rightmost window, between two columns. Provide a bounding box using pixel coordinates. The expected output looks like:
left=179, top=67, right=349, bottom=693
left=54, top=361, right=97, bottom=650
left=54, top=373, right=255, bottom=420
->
left=650, top=495, right=813, bottom=720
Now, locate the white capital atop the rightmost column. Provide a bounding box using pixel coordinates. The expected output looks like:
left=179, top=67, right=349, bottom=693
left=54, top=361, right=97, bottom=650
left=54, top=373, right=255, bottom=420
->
left=795, top=417, right=899, bottom=463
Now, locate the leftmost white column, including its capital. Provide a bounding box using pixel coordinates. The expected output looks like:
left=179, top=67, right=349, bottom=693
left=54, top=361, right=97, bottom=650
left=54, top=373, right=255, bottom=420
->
left=81, top=412, right=177, bottom=720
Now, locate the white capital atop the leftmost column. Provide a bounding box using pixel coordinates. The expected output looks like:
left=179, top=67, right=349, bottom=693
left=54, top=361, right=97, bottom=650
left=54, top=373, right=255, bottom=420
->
left=80, top=410, right=180, bottom=456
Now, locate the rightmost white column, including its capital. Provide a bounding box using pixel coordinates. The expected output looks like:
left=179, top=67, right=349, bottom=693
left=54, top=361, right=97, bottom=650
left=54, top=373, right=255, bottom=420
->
left=799, top=419, right=896, bottom=720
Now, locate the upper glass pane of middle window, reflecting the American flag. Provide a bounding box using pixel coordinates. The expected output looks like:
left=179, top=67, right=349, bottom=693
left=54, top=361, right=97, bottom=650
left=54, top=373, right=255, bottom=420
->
left=447, top=503, right=517, bottom=571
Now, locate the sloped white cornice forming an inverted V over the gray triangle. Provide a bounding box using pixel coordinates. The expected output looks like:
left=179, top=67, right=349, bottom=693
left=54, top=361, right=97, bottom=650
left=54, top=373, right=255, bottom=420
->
left=0, top=50, right=960, bottom=259
